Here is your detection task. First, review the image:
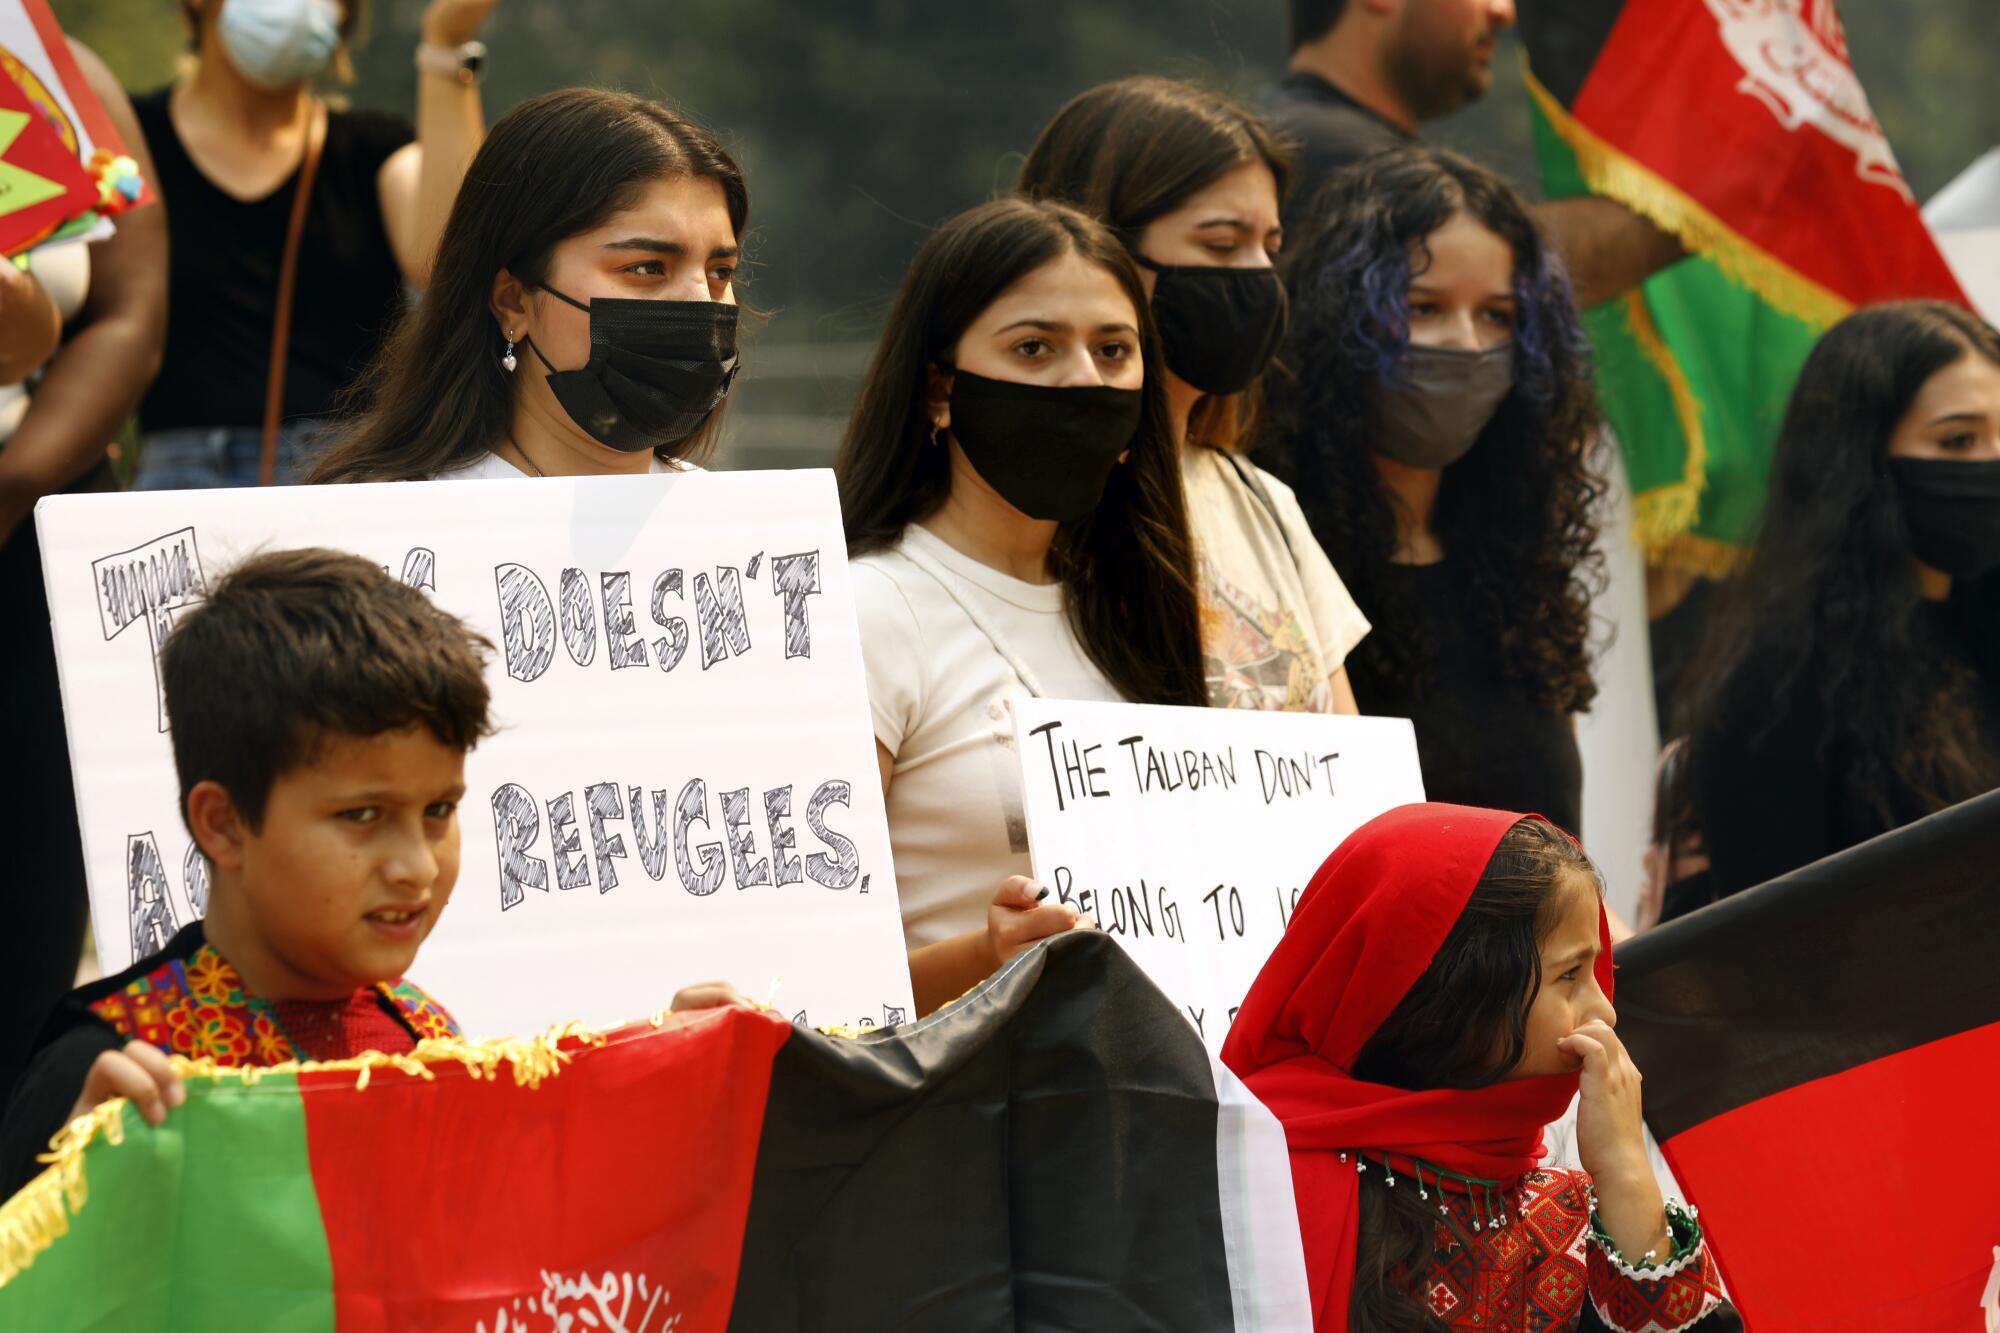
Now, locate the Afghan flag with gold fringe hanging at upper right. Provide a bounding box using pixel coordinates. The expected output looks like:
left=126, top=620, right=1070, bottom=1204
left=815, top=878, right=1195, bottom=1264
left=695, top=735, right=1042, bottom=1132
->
left=1520, top=0, right=1966, bottom=576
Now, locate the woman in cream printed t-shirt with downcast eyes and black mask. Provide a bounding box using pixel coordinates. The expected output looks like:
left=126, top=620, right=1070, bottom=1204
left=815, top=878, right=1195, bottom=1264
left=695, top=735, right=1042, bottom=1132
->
left=1018, top=78, right=1368, bottom=713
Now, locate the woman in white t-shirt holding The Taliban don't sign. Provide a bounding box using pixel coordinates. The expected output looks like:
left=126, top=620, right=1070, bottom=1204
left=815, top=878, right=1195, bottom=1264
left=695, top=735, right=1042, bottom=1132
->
left=836, top=200, right=1206, bottom=1011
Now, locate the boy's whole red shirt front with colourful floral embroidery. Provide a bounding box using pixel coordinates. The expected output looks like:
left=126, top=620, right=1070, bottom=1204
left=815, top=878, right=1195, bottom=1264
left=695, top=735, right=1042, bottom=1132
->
left=90, top=941, right=458, bottom=1065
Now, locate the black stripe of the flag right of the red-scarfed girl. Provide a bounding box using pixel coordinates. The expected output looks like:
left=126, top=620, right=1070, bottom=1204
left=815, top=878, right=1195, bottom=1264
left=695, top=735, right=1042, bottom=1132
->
left=1616, top=791, right=2000, bottom=1143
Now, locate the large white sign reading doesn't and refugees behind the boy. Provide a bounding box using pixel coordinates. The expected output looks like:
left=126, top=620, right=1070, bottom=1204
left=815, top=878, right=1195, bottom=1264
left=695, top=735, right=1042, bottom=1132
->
left=36, top=470, right=912, bottom=1037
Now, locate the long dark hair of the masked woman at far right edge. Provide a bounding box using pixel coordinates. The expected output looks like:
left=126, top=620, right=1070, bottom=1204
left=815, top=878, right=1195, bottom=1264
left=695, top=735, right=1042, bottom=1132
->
left=1694, top=300, right=2000, bottom=831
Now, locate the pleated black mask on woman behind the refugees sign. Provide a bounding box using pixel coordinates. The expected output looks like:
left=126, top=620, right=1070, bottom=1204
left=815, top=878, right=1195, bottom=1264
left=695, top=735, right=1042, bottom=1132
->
left=524, top=282, right=736, bottom=454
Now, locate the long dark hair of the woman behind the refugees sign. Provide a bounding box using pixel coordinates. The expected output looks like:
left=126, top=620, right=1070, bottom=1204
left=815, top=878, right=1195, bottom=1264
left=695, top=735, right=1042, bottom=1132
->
left=308, top=88, right=750, bottom=482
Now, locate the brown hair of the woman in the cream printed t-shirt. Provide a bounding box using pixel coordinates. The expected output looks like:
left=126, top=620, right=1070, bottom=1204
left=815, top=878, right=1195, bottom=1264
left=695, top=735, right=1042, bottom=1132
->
left=1014, top=76, right=1292, bottom=448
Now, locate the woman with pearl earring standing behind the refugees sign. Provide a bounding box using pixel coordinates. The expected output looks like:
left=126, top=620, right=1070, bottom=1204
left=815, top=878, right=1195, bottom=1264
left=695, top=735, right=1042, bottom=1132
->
left=310, top=88, right=750, bottom=482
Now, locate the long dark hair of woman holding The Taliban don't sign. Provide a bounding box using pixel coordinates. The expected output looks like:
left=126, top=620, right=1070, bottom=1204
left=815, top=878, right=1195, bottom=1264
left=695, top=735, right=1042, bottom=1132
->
left=834, top=200, right=1208, bottom=707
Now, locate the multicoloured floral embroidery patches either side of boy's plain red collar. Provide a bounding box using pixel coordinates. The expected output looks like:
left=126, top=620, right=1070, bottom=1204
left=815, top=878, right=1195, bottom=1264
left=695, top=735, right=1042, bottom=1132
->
left=90, top=945, right=458, bottom=1065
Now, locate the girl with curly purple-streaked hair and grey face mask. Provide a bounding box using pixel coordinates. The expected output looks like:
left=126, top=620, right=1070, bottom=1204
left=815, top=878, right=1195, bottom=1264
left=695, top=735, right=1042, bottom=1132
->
left=1266, top=146, right=1604, bottom=833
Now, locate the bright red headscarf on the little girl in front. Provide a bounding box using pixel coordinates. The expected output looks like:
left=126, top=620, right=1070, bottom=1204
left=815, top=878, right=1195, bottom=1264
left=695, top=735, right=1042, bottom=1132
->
left=1222, top=805, right=1612, bottom=1333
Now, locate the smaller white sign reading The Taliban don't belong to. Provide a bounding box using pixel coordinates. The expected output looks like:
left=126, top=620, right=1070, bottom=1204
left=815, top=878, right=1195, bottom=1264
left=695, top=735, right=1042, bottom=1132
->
left=1014, top=699, right=1424, bottom=1051
